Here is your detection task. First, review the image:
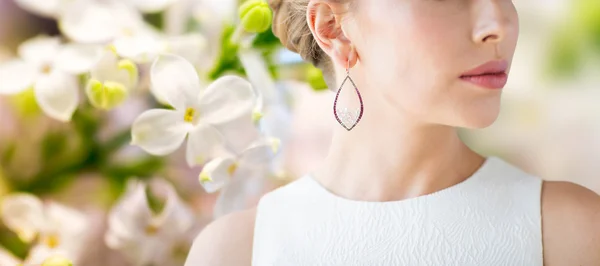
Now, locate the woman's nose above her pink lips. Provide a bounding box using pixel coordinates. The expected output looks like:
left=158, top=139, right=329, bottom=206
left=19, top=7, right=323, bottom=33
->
left=473, top=0, right=509, bottom=44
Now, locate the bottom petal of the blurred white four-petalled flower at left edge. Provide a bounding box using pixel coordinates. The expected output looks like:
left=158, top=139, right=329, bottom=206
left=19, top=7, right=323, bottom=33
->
left=34, top=70, right=79, bottom=122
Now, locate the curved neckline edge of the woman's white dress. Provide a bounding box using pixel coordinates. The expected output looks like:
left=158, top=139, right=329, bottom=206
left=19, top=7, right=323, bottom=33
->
left=304, top=156, right=499, bottom=205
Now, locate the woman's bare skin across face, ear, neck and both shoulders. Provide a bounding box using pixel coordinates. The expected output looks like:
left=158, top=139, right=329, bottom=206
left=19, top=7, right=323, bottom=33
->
left=186, top=0, right=600, bottom=266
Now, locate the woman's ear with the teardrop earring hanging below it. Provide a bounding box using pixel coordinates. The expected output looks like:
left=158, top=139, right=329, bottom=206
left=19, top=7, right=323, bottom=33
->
left=306, top=0, right=358, bottom=68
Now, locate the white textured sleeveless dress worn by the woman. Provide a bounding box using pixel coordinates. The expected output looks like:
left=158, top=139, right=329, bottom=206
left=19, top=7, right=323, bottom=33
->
left=252, top=156, right=543, bottom=266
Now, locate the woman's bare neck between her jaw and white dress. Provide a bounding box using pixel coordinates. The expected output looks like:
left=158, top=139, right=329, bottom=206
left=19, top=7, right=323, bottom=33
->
left=313, top=102, right=485, bottom=201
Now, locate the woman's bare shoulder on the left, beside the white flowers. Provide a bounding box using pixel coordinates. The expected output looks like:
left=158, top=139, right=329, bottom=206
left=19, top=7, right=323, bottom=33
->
left=185, top=208, right=256, bottom=266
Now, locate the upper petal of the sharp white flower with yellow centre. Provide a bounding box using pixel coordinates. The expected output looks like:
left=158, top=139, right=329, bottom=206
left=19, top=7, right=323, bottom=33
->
left=150, top=54, right=201, bottom=110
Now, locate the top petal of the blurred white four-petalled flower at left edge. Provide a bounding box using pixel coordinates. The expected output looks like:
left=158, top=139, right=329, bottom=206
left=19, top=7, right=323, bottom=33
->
left=18, top=35, right=60, bottom=69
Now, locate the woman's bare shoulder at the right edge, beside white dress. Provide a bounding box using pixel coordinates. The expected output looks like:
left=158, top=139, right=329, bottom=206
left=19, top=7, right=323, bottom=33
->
left=542, top=181, right=600, bottom=266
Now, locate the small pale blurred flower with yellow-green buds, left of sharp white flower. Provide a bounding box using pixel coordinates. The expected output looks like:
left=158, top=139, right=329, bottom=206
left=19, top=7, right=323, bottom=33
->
left=85, top=48, right=138, bottom=110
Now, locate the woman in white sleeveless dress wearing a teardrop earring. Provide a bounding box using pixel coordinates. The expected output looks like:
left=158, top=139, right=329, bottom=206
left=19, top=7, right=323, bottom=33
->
left=186, top=0, right=600, bottom=266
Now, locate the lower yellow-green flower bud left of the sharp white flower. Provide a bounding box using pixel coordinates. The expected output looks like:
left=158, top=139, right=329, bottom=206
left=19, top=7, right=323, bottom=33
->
left=86, top=79, right=129, bottom=110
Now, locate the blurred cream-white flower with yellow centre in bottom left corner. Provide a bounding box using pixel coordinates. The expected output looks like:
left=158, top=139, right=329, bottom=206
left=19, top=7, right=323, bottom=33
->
left=2, top=194, right=89, bottom=265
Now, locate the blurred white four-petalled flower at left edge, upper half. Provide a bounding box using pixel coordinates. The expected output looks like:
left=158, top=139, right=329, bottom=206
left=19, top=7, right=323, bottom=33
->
left=0, top=36, right=100, bottom=121
